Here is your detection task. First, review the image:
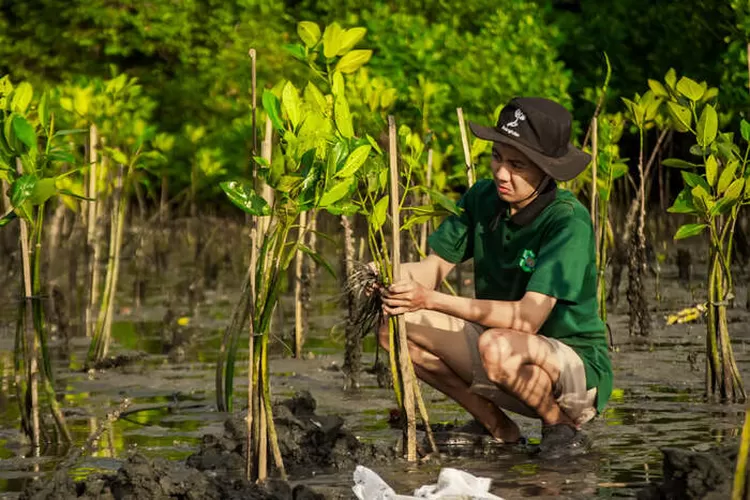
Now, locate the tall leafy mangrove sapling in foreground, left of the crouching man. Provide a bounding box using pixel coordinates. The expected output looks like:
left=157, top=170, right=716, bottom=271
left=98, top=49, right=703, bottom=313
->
left=216, top=21, right=384, bottom=480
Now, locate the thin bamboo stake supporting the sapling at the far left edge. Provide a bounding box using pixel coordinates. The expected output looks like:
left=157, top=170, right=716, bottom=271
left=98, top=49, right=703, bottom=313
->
left=16, top=157, right=40, bottom=456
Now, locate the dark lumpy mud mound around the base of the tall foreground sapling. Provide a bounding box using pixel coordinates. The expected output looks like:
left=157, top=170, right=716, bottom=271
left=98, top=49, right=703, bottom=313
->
left=20, top=391, right=396, bottom=500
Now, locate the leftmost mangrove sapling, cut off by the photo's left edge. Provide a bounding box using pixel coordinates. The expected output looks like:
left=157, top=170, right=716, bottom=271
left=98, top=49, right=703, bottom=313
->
left=0, top=77, right=75, bottom=446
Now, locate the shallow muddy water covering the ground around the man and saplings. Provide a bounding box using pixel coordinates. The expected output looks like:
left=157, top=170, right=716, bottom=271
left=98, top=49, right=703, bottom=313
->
left=0, top=260, right=750, bottom=499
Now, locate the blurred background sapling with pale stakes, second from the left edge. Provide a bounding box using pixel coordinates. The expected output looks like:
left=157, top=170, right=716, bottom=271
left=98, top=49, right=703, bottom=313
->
left=60, top=74, right=164, bottom=367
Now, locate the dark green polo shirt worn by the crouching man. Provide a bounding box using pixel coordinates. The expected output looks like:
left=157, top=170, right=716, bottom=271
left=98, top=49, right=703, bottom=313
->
left=429, top=180, right=613, bottom=412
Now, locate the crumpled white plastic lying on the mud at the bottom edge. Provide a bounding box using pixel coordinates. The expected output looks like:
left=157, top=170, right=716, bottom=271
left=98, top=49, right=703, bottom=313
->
left=352, top=465, right=503, bottom=500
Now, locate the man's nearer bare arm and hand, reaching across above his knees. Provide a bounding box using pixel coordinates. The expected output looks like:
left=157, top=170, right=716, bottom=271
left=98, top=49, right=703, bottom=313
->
left=383, top=280, right=557, bottom=334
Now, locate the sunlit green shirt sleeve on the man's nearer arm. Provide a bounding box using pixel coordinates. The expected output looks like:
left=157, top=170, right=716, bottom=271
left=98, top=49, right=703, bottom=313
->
left=526, top=216, right=595, bottom=303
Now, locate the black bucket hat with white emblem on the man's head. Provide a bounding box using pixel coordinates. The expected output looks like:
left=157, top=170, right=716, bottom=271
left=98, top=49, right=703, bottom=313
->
left=469, top=97, right=591, bottom=181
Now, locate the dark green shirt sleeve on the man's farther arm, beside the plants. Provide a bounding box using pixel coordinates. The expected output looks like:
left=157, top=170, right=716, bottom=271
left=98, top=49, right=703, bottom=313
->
left=427, top=189, right=474, bottom=264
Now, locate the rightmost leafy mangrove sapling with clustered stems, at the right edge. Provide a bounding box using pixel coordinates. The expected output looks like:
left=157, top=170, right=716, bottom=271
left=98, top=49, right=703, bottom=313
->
left=664, top=73, right=750, bottom=402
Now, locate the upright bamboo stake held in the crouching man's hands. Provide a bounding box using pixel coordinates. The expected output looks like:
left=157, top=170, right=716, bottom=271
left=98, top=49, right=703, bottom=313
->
left=388, top=116, right=417, bottom=462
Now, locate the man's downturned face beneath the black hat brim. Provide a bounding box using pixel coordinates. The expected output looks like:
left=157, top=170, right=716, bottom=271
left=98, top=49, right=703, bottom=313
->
left=491, top=142, right=544, bottom=204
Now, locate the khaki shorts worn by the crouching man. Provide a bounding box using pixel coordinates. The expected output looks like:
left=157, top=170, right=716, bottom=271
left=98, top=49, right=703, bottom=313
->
left=405, top=311, right=596, bottom=425
